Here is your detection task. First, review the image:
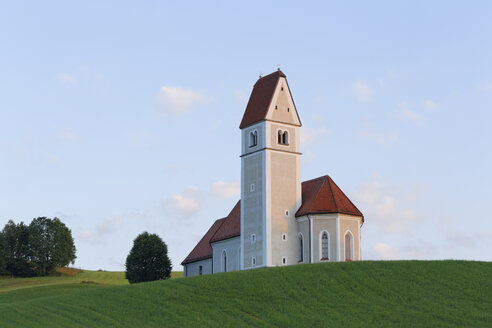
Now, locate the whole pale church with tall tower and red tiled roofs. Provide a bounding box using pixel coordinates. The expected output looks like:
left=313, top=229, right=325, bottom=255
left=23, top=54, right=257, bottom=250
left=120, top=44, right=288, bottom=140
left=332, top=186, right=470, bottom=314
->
left=181, top=69, right=364, bottom=277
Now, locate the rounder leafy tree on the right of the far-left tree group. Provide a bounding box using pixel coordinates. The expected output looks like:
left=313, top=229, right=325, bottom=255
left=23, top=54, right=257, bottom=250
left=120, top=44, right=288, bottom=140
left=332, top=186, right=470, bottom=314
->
left=29, top=217, right=77, bottom=275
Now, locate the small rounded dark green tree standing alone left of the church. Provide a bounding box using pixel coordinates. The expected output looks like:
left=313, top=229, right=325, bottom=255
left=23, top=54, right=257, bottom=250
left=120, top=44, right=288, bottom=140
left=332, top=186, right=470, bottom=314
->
left=126, top=231, right=172, bottom=284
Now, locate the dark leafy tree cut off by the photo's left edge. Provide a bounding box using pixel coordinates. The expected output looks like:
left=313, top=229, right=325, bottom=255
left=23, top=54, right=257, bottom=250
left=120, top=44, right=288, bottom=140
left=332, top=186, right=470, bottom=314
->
left=2, top=220, right=33, bottom=277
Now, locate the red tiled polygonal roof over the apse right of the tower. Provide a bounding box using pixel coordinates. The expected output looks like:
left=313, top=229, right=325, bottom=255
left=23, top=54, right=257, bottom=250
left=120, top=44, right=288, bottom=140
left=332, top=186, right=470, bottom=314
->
left=296, top=175, right=364, bottom=220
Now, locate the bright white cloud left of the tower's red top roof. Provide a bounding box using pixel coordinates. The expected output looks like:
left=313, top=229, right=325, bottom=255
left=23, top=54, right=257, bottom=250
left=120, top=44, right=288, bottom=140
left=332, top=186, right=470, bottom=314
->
left=157, top=86, right=205, bottom=115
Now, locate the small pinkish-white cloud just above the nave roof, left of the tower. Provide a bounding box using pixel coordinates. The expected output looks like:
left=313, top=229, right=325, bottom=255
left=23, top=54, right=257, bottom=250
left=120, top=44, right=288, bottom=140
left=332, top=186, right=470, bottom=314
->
left=164, top=187, right=202, bottom=217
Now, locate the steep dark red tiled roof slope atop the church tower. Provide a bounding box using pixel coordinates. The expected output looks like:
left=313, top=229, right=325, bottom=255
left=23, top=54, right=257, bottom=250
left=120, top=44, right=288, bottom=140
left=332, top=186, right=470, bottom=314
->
left=239, top=69, right=286, bottom=129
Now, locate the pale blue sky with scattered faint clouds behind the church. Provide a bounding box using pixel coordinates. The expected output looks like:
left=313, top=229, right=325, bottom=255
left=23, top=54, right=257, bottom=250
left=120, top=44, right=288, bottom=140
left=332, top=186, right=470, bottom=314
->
left=0, top=0, right=492, bottom=270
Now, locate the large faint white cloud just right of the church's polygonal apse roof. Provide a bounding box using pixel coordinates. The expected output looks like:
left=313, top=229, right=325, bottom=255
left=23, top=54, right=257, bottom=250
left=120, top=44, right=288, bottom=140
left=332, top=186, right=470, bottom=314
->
left=355, top=181, right=418, bottom=233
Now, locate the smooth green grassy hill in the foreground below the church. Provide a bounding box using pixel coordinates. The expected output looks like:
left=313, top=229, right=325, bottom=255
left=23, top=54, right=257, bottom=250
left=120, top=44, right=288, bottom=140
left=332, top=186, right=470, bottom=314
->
left=0, top=261, right=492, bottom=327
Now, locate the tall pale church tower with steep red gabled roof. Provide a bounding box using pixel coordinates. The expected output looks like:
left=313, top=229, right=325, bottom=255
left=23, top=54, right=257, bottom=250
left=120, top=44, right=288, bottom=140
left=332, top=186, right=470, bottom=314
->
left=239, top=69, right=304, bottom=269
